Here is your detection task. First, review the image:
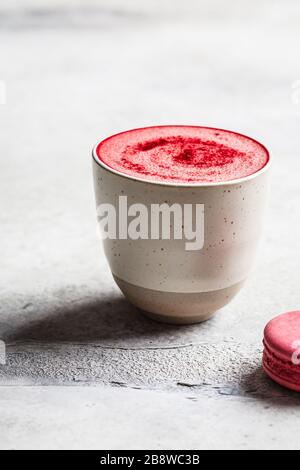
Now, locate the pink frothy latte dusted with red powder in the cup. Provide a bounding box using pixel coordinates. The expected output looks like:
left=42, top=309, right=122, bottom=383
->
left=96, top=126, right=269, bottom=184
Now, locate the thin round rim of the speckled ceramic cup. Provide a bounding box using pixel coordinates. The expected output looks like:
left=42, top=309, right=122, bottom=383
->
left=92, top=124, right=272, bottom=188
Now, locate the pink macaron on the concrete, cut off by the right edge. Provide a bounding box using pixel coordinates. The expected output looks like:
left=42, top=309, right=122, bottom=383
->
left=263, top=311, right=300, bottom=392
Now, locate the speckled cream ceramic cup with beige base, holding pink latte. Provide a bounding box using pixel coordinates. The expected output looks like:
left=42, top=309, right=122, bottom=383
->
left=93, top=126, right=270, bottom=324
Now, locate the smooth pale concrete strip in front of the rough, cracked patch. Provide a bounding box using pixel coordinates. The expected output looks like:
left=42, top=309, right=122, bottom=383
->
left=0, top=386, right=299, bottom=450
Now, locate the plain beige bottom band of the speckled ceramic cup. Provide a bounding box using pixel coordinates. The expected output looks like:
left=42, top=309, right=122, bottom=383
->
left=114, top=276, right=244, bottom=325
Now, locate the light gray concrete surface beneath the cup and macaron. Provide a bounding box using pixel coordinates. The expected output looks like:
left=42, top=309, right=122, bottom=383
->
left=0, top=0, right=300, bottom=449
